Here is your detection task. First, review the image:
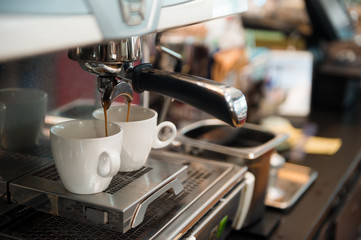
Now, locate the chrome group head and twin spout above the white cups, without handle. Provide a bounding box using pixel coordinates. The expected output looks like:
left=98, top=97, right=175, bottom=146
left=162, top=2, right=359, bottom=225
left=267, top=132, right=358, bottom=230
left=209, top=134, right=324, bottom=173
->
left=68, top=36, right=141, bottom=108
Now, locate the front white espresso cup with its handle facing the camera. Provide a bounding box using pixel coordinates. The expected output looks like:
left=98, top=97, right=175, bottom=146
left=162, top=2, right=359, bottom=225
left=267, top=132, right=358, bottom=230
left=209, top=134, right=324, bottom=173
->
left=50, top=120, right=123, bottom=194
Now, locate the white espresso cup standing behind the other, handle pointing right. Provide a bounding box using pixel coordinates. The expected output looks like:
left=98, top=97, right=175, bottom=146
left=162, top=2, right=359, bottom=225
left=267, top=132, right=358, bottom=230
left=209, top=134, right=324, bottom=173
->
left=93, top=105, right=177, bottom=172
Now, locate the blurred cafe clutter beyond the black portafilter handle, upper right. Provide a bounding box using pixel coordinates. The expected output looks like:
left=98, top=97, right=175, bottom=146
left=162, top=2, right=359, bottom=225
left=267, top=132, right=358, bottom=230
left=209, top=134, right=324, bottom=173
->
left=147, top=0, right=360, bottom=125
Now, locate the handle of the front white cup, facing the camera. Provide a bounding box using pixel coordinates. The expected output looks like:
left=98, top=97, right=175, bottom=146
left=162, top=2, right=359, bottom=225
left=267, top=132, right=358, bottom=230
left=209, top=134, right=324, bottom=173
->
left=97, top=151, right=120, bottom=177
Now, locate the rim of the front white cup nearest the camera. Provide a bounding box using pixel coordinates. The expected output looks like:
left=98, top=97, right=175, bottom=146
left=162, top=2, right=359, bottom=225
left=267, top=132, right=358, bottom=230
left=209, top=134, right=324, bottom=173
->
left=50, top=119, right=123, bottom=141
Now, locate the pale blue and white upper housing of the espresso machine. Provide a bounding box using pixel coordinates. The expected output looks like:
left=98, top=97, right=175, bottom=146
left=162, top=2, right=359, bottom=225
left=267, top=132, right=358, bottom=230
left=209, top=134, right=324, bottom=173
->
left=0, top=0, right=247, bottom=61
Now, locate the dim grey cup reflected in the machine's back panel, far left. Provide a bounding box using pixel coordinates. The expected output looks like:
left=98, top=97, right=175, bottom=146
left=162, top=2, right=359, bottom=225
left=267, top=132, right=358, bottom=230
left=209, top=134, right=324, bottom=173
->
left=0, top=88, right=47, bottom=150
